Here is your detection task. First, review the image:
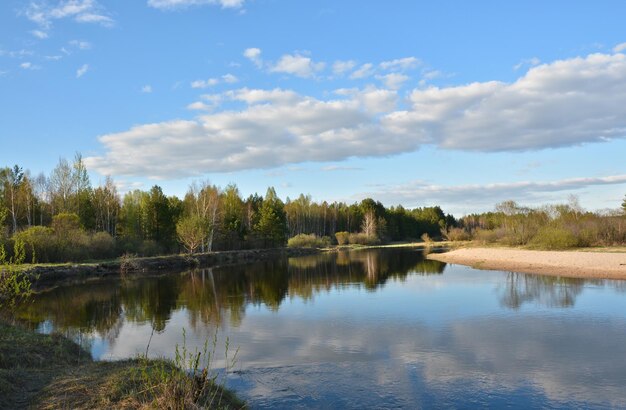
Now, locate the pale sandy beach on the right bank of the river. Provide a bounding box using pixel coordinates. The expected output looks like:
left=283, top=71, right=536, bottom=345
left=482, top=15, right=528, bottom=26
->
left=428, top=248, right=626, bottom=279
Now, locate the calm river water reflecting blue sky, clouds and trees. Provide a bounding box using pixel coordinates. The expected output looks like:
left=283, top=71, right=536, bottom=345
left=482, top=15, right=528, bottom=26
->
left=15, top=249, right=626, bottom=408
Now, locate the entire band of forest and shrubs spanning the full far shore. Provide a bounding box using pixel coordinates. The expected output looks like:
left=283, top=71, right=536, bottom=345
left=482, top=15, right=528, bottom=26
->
left=0, top=153, right=626, bottom=263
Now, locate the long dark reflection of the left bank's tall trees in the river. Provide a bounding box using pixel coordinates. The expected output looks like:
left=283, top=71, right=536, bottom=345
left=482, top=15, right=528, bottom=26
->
left=14, top=250, right=445, bottom=336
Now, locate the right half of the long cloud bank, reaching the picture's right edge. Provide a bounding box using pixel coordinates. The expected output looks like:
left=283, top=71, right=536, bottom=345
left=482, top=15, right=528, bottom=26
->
left=383, top=54, right=626, bottom=151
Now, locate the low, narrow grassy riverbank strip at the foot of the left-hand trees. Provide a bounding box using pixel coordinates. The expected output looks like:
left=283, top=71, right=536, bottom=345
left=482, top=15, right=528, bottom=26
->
left=15, top=248, right=319, bottom=290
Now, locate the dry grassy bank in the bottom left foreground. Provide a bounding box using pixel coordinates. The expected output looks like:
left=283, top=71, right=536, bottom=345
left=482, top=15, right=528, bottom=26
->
left=0, top=322, right=245, bottom=409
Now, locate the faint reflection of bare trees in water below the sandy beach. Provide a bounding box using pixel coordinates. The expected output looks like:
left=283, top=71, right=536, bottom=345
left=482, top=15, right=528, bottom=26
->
left=499, top=272, right=604, bottom=309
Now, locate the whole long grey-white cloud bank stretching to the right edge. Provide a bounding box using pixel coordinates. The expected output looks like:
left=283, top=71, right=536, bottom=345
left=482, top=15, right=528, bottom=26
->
left=90, top=54, right=626, bottom=177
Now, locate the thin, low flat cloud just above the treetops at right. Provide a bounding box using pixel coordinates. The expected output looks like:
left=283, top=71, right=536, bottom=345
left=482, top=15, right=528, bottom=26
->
left=358, top=175, right=626, bottom=208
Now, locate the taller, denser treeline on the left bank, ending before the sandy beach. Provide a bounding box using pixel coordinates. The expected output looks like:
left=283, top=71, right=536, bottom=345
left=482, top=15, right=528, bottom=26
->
left=0, top=154, right=457, bottom=262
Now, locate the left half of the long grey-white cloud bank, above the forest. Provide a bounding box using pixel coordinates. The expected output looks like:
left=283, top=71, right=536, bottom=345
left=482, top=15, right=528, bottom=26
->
left=86, top=89, right=404, bottom=178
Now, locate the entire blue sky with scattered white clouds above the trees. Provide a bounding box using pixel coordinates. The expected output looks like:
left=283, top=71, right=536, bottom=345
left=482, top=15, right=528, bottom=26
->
left=0, top=0, right=626, bottom=216
